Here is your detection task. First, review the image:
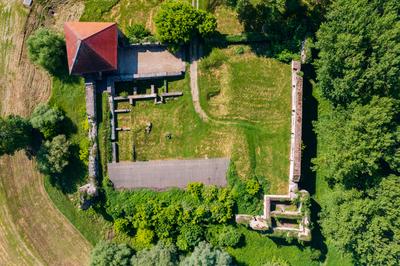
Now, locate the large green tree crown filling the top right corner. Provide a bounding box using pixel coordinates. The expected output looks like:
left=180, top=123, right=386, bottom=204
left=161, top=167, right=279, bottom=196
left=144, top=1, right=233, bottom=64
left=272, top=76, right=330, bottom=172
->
left=316, top=0, right=400, bottom=105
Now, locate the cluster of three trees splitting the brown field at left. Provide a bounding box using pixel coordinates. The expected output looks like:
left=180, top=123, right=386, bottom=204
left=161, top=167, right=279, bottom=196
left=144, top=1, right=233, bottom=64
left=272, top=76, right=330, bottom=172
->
left=0, top=104, right=70, bottom=185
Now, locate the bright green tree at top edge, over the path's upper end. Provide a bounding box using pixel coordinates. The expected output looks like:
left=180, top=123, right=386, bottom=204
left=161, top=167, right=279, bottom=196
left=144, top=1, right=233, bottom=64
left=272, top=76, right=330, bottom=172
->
left=155, top=0, right=217, bottom=45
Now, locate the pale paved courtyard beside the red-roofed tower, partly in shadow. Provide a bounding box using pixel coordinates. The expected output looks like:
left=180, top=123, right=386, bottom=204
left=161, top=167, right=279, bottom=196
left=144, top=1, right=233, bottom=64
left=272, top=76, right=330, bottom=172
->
left=118, top=45, right=185, bottom=75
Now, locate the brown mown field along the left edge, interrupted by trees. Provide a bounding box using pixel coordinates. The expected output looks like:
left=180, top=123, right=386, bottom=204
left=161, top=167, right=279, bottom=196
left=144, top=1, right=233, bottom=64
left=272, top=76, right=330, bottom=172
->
left=0, top=0, right=91, bottom=265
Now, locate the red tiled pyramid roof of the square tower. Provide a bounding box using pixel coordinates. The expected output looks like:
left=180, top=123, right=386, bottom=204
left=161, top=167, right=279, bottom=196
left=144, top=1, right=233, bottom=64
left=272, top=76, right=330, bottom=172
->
left=64, top=22, right=118, bottom=74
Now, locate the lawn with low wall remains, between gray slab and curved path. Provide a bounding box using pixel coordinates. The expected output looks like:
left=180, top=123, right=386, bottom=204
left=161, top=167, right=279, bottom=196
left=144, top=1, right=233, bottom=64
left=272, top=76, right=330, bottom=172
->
left=114, top=74, right=232, bottom=161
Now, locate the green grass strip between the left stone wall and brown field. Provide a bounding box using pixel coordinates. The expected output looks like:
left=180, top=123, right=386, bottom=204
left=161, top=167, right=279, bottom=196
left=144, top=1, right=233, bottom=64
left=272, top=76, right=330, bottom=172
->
left=45, top=75, right=110, bottom=245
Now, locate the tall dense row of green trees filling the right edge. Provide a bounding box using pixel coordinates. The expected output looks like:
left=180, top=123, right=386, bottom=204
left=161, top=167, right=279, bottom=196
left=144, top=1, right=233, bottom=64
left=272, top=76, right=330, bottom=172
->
left=314, top=0, right=400, bottom=265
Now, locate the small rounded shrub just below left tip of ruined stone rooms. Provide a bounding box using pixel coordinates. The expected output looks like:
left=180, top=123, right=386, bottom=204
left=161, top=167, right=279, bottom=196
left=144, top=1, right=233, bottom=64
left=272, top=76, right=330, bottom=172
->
left=206, top=225, right=242, bottom=247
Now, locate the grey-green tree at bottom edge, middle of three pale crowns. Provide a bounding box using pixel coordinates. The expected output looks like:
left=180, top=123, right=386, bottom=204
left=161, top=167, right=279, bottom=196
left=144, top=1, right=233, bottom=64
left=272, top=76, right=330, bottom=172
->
left=131, top=242, right=178, bottom=266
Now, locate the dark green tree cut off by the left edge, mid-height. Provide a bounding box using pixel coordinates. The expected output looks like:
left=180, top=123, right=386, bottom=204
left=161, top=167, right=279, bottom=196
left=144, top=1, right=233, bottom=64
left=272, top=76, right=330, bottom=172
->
left=0, top=115, right=32, bottom=156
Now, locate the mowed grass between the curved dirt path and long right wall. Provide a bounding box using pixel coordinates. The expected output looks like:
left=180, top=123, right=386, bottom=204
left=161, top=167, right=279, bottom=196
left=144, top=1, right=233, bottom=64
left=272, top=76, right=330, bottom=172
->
left=199, top=46, right=291, bottom=193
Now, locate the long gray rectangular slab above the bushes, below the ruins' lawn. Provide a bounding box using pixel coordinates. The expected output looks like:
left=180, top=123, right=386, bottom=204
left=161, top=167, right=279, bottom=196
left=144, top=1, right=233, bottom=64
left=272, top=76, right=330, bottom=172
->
left=108, top=158, right=229, bottom=190
